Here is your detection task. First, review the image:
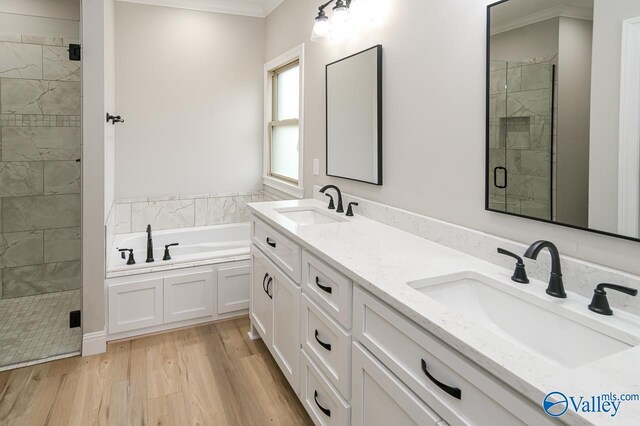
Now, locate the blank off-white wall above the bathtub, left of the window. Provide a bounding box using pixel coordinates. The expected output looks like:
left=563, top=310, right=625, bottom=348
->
left=113, top=2, right=265, bottom=199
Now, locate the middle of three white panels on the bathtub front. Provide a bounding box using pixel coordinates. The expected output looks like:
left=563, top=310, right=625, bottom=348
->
left=164, top=272, right=214, bottom=323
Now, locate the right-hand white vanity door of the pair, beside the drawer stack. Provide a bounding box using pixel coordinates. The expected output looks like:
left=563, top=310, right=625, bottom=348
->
left=270, top=266, right=301, bottom=393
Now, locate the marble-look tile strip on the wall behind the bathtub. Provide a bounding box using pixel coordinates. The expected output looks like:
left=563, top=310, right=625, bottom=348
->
left=111, top=191, right=280, bottom=234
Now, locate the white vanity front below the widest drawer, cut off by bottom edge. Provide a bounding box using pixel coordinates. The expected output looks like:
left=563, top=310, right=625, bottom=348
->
left=351, top=343, right=441, bottom=426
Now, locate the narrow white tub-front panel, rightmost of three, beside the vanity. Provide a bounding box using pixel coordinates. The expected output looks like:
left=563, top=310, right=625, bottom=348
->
left=218, top=265, right=251, bottom=314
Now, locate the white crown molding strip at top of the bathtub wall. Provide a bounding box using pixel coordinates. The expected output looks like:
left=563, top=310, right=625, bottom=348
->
left=118, top=0, right=283, bottom=18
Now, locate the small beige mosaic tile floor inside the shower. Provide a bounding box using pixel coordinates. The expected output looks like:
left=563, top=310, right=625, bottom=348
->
left=0, top=290, right=82, bottom=371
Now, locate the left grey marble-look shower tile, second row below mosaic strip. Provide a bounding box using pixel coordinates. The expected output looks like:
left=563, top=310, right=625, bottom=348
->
left=0, top=161, right=43, bottom=197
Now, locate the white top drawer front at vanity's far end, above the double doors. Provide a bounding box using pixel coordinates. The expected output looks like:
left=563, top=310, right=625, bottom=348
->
left=251, top=218, right=302, bottom=284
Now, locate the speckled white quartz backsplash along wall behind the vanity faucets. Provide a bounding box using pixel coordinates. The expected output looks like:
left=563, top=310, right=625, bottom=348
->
left=314, top=185, right=640, bottom=315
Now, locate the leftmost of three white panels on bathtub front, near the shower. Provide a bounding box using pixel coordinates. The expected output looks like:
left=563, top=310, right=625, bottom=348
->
left=108, top=278, right=163, bottom=334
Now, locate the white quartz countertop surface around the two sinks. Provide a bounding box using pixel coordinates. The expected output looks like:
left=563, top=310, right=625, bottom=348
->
left=249, top=200, right=640, bottom=425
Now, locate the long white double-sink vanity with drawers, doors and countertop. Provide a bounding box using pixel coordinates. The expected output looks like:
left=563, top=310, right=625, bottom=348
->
left=249, top=196, right=640, bottom=426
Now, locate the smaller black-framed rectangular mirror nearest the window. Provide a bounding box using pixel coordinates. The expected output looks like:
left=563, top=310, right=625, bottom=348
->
left=326, top=45, right=382, bottom=185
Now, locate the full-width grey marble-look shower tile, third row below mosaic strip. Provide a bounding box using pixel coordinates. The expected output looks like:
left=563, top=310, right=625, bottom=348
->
left=2, top=194, right=80, bottom=232
